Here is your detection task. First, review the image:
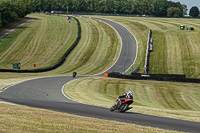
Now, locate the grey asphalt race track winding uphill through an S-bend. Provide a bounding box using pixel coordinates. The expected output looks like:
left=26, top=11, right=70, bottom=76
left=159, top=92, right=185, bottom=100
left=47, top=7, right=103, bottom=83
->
left=0, top=16, right=200, bottom=132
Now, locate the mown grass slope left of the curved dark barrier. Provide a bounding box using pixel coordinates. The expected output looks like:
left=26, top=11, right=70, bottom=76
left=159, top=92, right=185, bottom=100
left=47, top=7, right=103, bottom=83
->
left=0, top=14, right=78, bottom=69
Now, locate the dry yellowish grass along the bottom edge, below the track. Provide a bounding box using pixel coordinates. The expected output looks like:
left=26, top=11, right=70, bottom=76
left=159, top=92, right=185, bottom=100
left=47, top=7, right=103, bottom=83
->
left=0, top=103, right=181, bottom=133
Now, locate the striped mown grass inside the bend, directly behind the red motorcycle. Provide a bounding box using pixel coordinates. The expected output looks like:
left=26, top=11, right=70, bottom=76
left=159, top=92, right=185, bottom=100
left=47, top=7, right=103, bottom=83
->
left=64, top=77, right=200, bottom=122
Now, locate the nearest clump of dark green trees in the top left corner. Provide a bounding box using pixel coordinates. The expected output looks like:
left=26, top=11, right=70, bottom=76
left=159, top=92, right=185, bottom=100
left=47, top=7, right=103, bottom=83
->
left=0, top=0, right=35, bottom=27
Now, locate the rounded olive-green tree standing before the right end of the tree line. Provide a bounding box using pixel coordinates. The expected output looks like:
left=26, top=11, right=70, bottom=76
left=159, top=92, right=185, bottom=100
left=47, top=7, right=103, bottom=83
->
left=167, top=7, right=182, bottom=18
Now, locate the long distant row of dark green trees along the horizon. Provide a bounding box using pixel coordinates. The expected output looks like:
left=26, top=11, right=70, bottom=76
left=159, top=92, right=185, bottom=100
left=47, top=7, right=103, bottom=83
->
left=34, top=0, right=187, bottom=17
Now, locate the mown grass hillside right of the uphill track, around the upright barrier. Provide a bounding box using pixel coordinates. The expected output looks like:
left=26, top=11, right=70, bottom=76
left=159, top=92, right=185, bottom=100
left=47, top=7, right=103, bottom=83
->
left=92, top=16, right=200, bottom=78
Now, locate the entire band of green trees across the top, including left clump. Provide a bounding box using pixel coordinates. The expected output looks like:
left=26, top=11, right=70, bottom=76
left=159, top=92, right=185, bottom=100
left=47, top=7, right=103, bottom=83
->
left=0, top=0, right=187, bottom=26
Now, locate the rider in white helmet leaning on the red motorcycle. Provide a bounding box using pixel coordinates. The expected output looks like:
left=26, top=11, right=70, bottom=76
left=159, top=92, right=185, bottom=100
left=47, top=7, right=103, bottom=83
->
left=115, top=91, right=133, bottom=108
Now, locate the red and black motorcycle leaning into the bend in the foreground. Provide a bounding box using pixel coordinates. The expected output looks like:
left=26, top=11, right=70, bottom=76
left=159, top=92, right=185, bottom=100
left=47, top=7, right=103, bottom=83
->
left=110, top=98, right=133, bottom=113
